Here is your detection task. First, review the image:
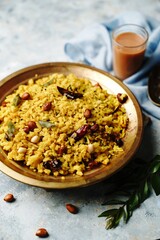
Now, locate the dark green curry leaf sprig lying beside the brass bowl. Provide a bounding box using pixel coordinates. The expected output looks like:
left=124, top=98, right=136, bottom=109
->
left=99, top=155, right=160, bottom=229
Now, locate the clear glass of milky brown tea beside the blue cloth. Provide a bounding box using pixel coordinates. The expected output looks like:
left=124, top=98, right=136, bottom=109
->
left=112, top=24, right=148, bottom=80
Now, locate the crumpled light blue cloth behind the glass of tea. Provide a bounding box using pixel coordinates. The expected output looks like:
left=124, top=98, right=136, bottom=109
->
left=64, top=11, right=160, bottom=119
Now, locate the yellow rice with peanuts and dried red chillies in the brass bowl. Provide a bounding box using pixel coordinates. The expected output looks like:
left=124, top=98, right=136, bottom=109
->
left=0, top=73, right=128, bottom=176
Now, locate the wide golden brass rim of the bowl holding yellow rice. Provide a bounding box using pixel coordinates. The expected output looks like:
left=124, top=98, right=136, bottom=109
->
left=0, top=62, right=143, bottom=189
